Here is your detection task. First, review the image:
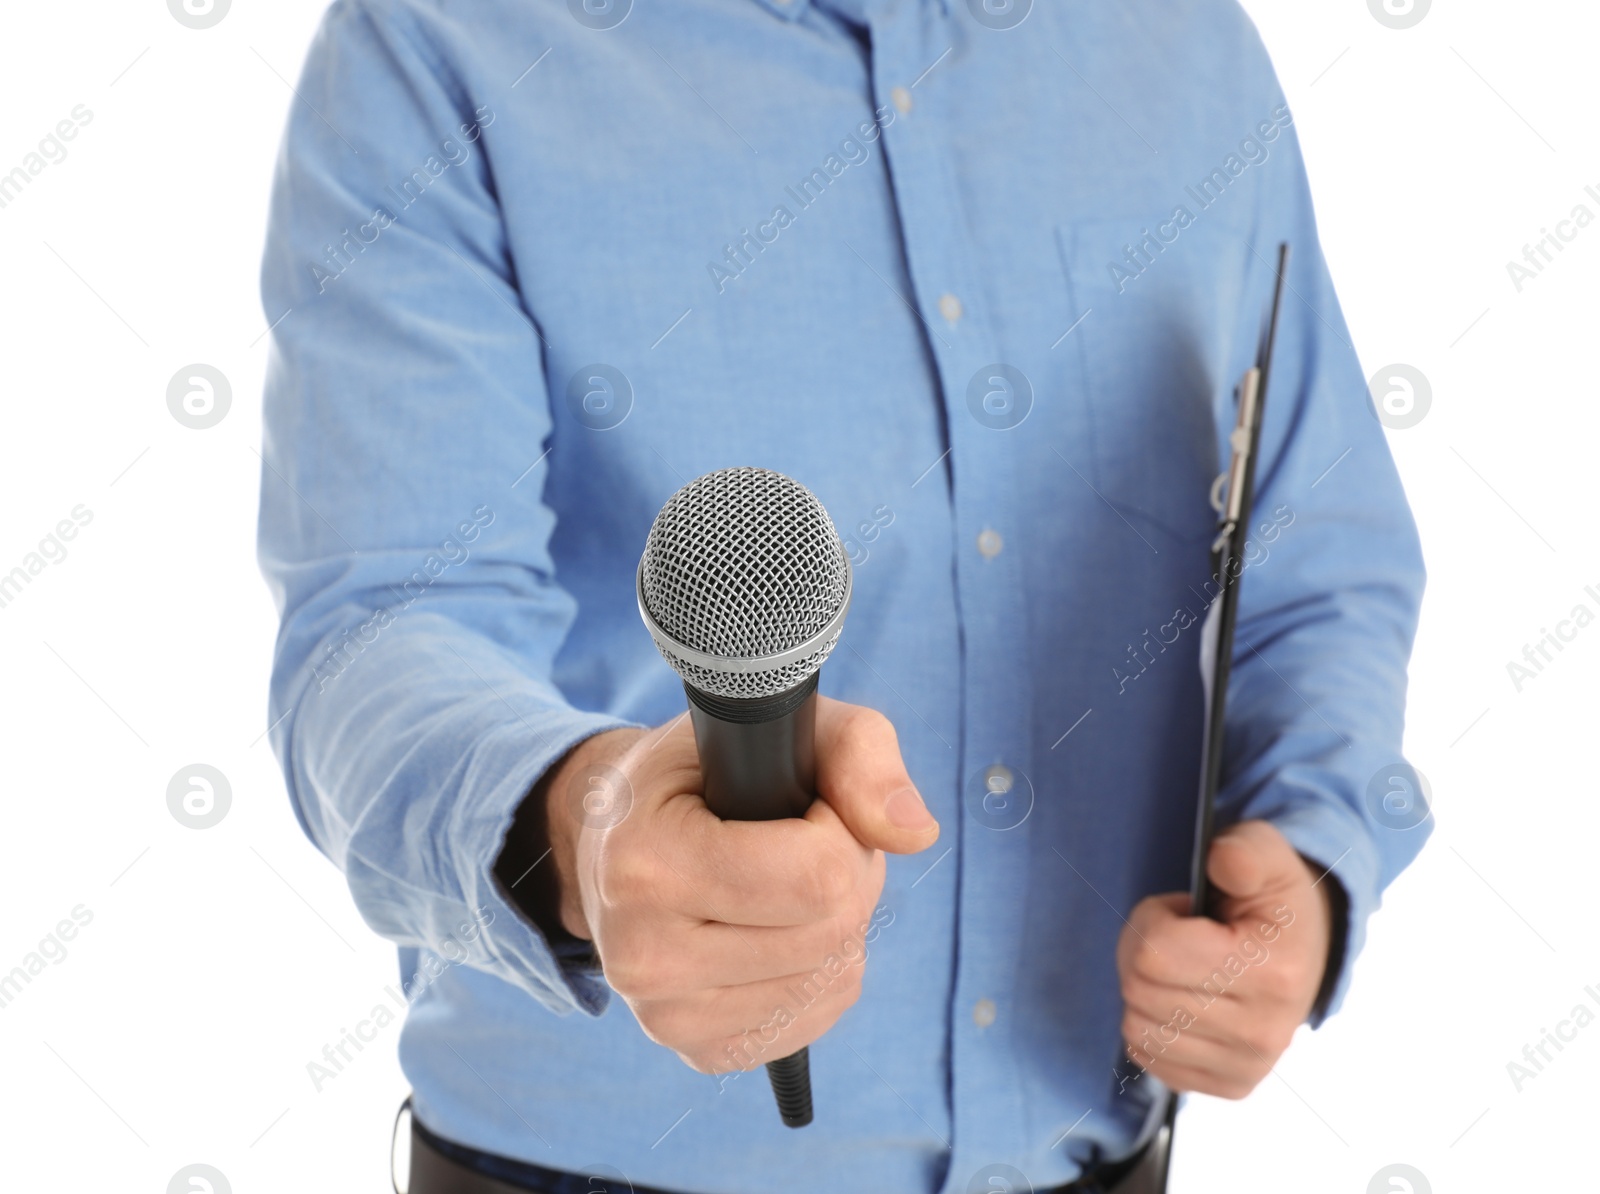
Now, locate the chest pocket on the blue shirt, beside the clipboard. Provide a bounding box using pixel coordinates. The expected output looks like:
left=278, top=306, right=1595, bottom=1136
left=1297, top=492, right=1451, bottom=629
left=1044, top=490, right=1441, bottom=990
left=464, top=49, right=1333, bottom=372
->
left=1056, top=219, right=1242, bottom=549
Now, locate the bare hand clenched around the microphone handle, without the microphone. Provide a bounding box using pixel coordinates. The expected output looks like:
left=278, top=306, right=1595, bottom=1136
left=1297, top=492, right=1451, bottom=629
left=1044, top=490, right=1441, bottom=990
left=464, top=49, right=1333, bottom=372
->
left=498, top=696, right=939, bottom=1074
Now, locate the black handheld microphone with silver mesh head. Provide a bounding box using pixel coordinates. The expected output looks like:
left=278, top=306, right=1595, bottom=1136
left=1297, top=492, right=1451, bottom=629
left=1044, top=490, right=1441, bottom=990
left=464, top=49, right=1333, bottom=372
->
left=637, top=467, right=851, bottom=1128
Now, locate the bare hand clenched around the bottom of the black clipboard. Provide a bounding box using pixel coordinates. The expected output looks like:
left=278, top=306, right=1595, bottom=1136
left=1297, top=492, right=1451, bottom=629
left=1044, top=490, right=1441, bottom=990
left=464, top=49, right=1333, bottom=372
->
left=1117, top=821, right=1334, bottom=1098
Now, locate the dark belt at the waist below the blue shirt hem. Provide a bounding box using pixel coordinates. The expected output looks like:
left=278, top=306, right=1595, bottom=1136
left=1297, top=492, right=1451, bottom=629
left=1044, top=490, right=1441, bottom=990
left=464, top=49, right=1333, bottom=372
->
left=395, top=1098, right=1166, bottom=1194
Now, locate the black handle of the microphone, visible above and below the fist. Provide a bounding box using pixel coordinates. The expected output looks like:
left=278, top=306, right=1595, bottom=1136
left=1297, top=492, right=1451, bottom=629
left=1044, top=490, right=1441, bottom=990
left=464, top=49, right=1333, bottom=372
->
left=683, top=672, right=818, bottom=1128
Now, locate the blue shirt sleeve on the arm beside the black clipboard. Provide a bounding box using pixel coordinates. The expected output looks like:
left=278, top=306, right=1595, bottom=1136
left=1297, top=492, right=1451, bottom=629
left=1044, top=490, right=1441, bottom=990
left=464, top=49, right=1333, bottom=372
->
left=1219, top=94, right=1432, bottom=1023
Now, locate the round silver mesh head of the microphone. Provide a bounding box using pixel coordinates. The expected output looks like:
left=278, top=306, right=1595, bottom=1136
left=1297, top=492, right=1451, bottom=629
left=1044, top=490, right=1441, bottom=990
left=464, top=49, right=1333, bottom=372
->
left=637, top=467, right=851, bottom=699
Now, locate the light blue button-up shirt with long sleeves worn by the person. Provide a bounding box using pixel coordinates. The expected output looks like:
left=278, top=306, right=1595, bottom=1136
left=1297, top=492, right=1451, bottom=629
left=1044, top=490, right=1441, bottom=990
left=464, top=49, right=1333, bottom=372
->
left=261, top=0, right=1427, bottom=1194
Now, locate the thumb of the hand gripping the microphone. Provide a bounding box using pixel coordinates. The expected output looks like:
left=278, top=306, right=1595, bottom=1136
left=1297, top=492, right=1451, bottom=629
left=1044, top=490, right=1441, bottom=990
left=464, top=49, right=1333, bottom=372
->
left=816, top=696, right=939, bottom=855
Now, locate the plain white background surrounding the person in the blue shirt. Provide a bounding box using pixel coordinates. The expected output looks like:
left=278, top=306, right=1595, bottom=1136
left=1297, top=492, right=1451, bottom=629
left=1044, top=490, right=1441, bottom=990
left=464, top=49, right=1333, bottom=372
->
left=0, top=0, right=1600, bottom=1194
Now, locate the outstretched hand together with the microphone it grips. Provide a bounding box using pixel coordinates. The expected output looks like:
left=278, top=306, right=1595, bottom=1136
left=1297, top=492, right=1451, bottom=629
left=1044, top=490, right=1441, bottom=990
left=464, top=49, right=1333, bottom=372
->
left=549, top=469, right=939, bottom=1127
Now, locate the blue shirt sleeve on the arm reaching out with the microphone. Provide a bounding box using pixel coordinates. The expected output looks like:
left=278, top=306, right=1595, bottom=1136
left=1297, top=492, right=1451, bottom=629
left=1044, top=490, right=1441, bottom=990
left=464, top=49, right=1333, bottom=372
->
left=259, top=3, right=622, bottom=1013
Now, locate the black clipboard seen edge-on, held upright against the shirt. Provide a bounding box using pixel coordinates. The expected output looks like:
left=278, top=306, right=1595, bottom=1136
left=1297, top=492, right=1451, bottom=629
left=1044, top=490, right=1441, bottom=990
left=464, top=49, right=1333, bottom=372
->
left=1130, top=243, right=1290, bottom=1194
